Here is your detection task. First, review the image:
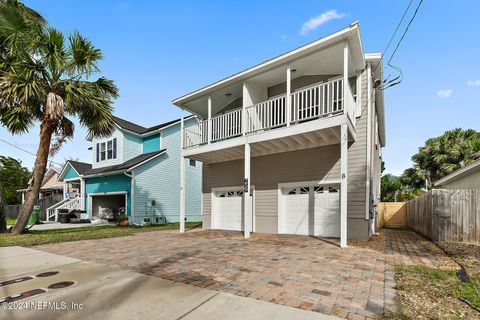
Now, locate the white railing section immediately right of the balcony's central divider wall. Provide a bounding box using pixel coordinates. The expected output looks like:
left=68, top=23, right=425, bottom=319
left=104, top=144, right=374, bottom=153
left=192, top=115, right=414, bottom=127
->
left=245, top=96, right=287, bottom=133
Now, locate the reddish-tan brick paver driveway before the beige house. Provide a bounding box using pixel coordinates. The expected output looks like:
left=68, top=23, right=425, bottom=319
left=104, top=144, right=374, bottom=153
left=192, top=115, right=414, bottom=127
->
left=37, top=230, right=435, bottom=319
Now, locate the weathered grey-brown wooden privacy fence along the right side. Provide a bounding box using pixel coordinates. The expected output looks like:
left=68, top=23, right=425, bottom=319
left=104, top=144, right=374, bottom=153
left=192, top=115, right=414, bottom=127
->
left=407, top=190, right=480, bottom=242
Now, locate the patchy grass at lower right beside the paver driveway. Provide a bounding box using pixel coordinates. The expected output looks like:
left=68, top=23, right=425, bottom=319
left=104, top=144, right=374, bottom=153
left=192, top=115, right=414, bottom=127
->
left=395, top=243, right=480, bottom=319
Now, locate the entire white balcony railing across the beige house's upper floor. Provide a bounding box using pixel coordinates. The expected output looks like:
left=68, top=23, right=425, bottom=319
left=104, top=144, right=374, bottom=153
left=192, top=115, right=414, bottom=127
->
left=183, top=78, right=356, bottom=149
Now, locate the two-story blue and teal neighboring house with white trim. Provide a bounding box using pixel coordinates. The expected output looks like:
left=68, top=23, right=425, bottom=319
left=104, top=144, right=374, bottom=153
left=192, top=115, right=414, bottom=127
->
left=54, top=117, right=202, bottom=224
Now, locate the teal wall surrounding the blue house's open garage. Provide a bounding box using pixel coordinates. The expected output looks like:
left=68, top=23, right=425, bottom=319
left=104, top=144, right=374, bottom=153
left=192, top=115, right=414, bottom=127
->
left=85, top=174, right=131, bottom=216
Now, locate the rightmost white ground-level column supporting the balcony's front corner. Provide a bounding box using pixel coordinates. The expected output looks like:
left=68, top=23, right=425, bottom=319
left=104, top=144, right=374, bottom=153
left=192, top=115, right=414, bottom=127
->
left=340, top=123, right=348, bottom=248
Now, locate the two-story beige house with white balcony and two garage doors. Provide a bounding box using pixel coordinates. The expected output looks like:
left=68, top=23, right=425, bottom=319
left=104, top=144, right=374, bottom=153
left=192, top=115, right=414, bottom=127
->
left=173, top=23, right=385, bottom=246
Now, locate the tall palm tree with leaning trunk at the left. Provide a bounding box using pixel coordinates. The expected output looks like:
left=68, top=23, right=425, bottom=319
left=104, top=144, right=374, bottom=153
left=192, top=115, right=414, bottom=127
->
left=0, top=0, right=118, bottom=233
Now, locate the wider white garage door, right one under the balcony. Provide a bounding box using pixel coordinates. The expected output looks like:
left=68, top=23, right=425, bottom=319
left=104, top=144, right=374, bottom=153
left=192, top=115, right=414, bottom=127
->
left=279, top=185, right=340, bottom=237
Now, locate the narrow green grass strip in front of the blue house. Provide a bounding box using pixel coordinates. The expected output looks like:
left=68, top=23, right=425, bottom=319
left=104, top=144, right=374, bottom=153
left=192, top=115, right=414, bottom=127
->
left=0, top=222, right=201, bottom=247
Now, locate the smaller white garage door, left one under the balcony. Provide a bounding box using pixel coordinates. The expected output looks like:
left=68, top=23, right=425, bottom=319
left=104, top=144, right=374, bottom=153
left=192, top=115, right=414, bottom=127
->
left=212, top=189, right=243, bottom=231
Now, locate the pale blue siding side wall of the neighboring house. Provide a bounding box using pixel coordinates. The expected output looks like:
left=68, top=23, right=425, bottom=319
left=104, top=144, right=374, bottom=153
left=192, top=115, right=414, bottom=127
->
left=134, top=121, right=202, bottom=223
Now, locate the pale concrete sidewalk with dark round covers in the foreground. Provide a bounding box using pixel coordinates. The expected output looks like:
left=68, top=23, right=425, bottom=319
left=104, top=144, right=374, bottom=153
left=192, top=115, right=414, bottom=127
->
left=0, top=247, right=338, bottom=320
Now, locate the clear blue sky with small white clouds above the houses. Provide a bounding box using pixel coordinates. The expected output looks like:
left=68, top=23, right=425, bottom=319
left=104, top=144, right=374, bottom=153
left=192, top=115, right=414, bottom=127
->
left=0, top=0, right=480, bottom=174
